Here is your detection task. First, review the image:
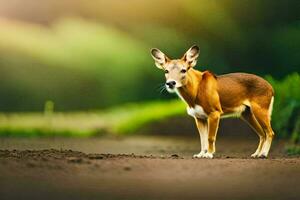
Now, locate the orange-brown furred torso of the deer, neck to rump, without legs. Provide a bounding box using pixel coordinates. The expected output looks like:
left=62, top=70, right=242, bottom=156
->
left=178, top=69, right=274, bottom=114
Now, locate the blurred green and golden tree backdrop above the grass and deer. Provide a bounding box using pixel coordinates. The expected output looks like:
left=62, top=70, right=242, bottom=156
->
left=0, top=0, right=300, bottom=111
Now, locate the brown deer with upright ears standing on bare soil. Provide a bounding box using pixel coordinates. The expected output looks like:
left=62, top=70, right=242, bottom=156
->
left=150, top=45, right=274, bottom=158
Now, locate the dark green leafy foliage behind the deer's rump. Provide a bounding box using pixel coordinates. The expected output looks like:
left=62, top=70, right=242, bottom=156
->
left=267, top=73, right=300, bottom=142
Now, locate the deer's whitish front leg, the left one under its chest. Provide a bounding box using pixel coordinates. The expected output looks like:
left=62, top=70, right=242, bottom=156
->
left=193, top=117, right=208, bottom=158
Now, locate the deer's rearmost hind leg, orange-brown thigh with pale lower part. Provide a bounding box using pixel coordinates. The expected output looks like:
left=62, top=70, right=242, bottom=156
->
left=253, top=101, right=274, bottom=158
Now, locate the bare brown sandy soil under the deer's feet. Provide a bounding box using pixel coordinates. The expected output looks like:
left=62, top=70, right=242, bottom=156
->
left=0, top=136, right=300, bottom=199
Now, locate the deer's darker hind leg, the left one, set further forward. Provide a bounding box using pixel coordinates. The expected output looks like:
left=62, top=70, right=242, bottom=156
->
left=241, top=107, right=266, bottom=158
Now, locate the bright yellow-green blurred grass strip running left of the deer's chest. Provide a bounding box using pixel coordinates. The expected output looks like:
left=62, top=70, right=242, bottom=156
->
left=0, top=100, right=185, bottom=137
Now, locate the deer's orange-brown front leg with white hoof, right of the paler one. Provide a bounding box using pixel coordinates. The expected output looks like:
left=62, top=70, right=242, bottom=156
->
left=203, top=111, right=221, bottom=158
